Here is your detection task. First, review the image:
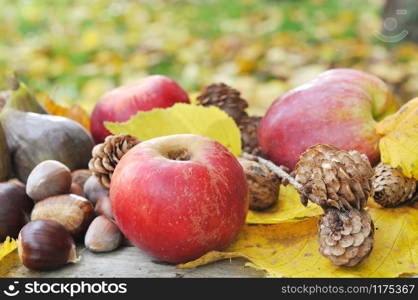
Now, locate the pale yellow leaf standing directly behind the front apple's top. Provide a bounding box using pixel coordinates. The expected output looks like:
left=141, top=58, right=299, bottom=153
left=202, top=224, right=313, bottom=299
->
left=105, top=103, right=241, bottom=156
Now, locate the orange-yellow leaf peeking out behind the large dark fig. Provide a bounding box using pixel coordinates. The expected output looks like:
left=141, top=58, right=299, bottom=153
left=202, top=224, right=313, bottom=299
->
left=42, top=97, right=90, bottom=130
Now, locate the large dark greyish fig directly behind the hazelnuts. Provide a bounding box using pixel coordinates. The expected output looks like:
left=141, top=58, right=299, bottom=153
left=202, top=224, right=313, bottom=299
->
left=1, top=109, right=93, bottom=182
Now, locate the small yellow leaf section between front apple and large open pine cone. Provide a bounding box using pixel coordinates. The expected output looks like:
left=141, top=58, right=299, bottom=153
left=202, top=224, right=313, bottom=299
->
left=247, top=185, right=322, bottom=224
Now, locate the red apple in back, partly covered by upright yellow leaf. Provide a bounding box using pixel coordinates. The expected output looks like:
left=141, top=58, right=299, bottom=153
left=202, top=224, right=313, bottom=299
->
left=90, top=75, right=189, bottom=143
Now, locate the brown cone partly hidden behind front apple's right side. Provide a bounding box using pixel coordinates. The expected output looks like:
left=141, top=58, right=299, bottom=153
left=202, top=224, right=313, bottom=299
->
left=238, top=157, right=280, bottom=210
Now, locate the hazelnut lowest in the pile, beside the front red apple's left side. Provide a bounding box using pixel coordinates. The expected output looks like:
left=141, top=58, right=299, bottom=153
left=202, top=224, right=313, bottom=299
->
left=84, top=216, right=123, bottom=252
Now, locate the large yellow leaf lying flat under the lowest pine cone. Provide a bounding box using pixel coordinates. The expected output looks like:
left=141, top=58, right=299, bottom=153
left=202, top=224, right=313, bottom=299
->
left=178, top=207, right=418, bottom=277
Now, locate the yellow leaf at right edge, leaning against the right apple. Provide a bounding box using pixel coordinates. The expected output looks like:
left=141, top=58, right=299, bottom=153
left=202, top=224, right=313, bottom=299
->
left=376, top=98, right=418, bottom=180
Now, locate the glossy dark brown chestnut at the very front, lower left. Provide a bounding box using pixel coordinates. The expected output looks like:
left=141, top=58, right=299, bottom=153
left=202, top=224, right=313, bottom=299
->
left=17, top=220, right=78, bottom=270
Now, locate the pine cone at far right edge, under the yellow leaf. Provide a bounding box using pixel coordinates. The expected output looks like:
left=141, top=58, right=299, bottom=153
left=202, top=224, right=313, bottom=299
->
left=373, top=163, right=418, bottom=207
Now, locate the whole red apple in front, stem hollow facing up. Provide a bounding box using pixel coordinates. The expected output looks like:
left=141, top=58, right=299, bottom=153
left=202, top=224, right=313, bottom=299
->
left=110, top=134, right=248, bottom=263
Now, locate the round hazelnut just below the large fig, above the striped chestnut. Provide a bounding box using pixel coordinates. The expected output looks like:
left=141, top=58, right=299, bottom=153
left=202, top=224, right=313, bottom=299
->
left=26, top=160, right=71, bottom=202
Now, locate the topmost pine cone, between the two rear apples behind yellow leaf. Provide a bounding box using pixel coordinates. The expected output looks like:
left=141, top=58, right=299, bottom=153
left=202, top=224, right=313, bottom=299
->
left=197, top=83, right=248, bottom=124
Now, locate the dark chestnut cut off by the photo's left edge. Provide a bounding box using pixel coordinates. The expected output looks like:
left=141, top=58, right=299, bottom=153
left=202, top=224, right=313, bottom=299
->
left=0, top=180, right=33, bottom=241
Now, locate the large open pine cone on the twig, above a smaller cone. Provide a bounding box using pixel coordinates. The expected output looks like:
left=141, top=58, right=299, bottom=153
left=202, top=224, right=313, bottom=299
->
left=294, top=145, right=374, bottom=210
